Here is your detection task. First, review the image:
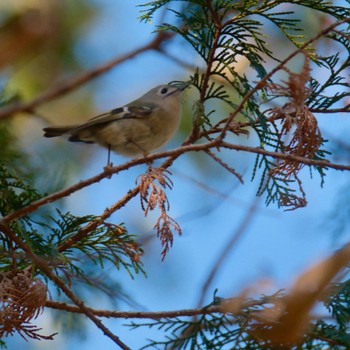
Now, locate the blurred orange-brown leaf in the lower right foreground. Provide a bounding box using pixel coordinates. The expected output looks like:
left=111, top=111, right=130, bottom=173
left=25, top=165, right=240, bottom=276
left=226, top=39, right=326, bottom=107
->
left=247, top=244, right=350, bottom=349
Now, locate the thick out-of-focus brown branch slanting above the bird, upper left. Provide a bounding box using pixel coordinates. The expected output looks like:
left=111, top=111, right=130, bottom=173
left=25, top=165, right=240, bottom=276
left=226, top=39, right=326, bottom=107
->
left=0, top=32, right=174, bottom=119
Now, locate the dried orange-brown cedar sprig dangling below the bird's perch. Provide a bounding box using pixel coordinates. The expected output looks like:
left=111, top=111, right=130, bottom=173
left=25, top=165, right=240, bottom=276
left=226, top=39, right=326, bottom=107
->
left=137, top=167, right=181, bottom=259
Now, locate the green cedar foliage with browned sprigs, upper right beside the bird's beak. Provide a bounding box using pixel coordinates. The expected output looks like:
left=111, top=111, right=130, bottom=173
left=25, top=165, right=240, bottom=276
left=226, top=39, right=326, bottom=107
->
left=140, top=0, right=350, bottom=210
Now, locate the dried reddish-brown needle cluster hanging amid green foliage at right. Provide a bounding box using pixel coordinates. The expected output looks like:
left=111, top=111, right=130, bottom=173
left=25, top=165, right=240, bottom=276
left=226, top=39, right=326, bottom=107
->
left=268, top=57, right=322, bottom=207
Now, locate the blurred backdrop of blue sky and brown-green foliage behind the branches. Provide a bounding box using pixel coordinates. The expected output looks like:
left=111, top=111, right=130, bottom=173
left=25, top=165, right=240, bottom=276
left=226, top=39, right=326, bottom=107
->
left=0, top=0, right=350, bottom=350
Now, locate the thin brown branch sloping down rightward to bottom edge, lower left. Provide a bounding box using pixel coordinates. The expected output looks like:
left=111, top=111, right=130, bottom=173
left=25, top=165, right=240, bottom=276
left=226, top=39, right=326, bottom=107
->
left=0, top=222, right=130, bottom=350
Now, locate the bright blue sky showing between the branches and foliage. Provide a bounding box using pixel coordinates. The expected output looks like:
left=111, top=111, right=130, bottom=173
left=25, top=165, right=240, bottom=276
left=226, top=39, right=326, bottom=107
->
left=6, top=0, right=350, bottom=350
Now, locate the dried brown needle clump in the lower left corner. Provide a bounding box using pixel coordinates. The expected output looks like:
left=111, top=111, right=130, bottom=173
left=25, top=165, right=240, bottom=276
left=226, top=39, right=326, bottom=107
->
left=0, top=270, right=55, bottom=340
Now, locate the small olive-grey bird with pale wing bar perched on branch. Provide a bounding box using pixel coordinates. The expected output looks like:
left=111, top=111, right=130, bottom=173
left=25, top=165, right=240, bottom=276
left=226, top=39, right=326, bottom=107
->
left=43, top=83, right=188, bottom=164
